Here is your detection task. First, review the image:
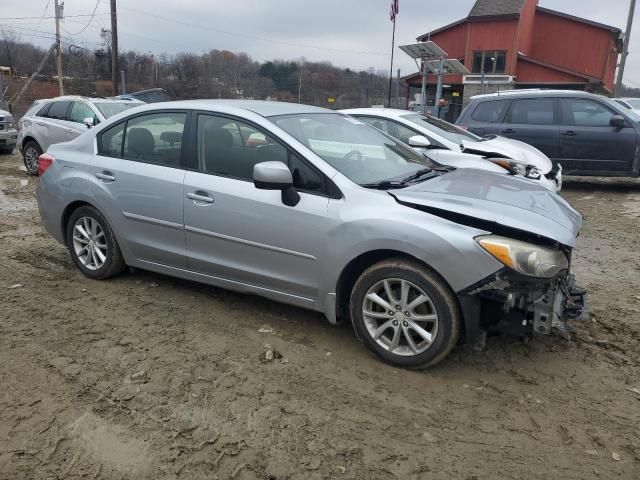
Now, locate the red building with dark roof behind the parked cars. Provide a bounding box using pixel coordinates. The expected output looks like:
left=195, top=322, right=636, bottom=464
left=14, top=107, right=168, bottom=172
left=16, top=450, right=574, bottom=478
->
left=405, top=0, right=622, bottom=119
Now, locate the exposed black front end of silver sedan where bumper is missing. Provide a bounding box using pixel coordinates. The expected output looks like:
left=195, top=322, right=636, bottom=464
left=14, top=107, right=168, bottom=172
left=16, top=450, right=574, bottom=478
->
left=458, top=269, right=587, bottom=348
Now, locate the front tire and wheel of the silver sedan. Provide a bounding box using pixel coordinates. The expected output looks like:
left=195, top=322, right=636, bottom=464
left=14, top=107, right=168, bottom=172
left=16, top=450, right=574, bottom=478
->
left=350, top=259, right=462, bottom=369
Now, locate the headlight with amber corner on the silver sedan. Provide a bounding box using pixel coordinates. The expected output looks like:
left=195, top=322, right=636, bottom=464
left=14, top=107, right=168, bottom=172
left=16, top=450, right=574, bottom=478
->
left=476, top=235, right=569, bottom=278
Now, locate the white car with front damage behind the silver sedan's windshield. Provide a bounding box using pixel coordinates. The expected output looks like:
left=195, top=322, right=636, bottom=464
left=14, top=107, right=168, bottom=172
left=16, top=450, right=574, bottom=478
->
left=341, top=108, right=562, bottom=192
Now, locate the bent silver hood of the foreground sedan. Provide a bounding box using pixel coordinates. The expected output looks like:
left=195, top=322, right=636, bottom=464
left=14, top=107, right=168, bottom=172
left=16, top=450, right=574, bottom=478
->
left=390, top=168, right=582, bottom=247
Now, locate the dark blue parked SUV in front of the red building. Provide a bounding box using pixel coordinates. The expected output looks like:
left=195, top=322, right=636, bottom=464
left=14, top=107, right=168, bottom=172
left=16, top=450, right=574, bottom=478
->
left=457, top=90, right=640, bottom=177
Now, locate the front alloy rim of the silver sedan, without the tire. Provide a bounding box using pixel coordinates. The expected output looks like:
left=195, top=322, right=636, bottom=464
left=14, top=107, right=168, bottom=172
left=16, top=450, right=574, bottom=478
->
left=362, top=278, right=438, bottom=356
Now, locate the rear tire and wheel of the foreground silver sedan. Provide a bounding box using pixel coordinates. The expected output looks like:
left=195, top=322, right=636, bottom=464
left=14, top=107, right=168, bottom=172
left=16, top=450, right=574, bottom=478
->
left=66, top=206, right=126, bottom=280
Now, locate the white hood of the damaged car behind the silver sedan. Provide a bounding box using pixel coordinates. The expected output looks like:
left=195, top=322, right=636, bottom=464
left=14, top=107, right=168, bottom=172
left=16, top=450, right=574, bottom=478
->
left=462, top=137, right=553, bottom=175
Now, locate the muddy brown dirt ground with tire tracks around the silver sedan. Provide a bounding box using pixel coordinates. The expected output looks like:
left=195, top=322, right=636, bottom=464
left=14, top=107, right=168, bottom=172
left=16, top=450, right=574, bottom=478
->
left=0, top=155, right=640, bottom=480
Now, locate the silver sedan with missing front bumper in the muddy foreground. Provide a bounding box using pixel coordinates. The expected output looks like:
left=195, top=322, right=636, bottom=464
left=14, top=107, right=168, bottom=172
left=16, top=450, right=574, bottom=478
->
left=37, top=100, right=584, bottom=368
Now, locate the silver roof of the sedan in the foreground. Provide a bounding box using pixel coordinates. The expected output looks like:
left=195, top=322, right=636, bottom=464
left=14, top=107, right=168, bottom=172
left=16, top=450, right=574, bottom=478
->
left=120, top=99, right=335, bottom=117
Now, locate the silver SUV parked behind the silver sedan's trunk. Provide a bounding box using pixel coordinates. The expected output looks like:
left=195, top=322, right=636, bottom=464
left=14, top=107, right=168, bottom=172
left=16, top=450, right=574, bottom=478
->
left=17, top=96, right=142, bottom=175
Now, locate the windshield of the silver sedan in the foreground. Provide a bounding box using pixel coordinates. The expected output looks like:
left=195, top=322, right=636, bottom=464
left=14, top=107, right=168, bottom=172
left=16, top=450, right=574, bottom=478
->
left=269, top=113, right=436, bottom=185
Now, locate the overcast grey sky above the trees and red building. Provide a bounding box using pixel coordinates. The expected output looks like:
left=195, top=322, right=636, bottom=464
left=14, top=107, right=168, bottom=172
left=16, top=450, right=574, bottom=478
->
left=5, top=0, right=640, bottom=87
